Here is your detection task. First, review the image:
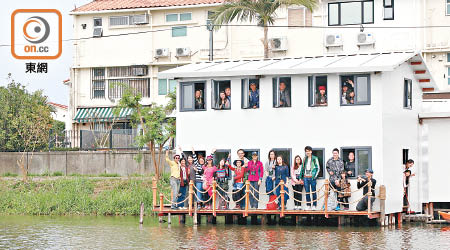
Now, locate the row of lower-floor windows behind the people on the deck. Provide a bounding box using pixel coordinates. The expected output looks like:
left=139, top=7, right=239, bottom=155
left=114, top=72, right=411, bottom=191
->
left=183, top=147, right=372, bottom=178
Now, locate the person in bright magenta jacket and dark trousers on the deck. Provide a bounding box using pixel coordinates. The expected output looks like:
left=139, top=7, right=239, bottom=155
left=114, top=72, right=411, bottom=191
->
left=245, top=151, right=264, bottom=209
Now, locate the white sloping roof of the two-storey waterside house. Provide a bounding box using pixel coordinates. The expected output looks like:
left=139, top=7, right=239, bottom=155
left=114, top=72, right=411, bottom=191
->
left=158, top=52, right=435, bottom=88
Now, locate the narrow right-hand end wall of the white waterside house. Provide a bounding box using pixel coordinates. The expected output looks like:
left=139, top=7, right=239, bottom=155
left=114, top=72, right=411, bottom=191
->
left=382, top=63, right=422, bottom=213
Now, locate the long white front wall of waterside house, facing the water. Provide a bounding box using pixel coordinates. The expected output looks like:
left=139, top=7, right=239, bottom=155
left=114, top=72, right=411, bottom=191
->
left=177, top=74, right=383, bottom=211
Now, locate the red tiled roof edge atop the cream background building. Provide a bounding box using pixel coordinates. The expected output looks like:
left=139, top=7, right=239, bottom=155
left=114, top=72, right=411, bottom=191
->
left=72, top=0, right=225, bottom=12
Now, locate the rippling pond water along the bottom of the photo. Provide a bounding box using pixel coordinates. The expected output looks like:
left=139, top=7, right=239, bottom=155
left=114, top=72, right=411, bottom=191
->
left=0, top=216, right=450, bottom=249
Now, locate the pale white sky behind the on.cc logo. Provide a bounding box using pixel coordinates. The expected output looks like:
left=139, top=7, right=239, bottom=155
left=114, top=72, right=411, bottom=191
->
left=0, top=0, right=92, bottom=105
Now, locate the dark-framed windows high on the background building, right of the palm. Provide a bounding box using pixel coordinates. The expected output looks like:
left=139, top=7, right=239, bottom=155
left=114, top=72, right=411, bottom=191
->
left=328, top=0, right=396, bottom=26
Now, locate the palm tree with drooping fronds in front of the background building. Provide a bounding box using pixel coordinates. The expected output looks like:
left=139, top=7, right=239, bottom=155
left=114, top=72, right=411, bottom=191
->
left=212, top=0, right=317, bottom=58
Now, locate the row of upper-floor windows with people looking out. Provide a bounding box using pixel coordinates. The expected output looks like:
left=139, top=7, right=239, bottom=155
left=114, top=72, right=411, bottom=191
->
left=180, top=74, right=370, bottom=111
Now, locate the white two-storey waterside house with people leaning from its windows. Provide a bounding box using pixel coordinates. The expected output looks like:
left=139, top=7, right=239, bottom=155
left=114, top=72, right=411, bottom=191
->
left=159, top=52, right=434, bottom=213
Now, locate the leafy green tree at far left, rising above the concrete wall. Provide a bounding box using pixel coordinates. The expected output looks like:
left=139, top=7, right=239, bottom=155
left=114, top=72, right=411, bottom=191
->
left=0, top=74, right=52, bottom=181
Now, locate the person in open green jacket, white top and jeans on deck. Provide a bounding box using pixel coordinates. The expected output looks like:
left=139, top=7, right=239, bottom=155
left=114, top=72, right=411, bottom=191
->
left=300, top=146, right=320, bottom=210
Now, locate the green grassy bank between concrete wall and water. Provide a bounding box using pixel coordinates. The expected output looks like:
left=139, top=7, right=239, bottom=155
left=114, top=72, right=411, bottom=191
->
left=0, top=177, right=170, bottom=215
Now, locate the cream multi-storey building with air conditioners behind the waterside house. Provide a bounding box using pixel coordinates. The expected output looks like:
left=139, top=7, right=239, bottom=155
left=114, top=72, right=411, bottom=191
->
left=69, top=0, right=450, bottom=147
